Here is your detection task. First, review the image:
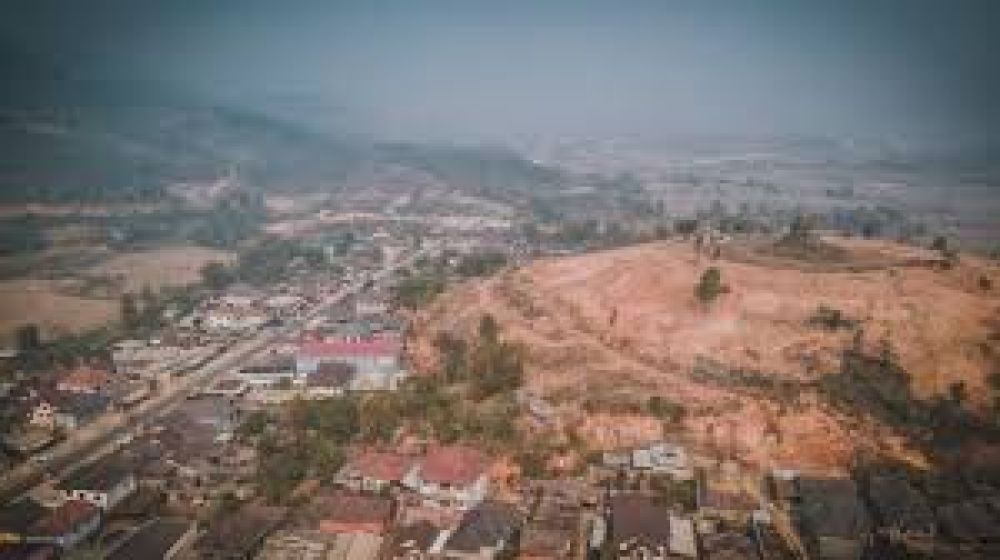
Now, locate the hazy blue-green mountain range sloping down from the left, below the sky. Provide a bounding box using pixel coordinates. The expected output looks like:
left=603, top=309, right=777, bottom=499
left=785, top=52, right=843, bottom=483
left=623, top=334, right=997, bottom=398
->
left=0, top=49, right=558, bottom=203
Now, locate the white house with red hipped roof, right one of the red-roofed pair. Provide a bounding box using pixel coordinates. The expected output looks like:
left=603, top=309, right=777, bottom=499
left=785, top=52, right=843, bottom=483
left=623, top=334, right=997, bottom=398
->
left=404, top=446, right=489, bottom=509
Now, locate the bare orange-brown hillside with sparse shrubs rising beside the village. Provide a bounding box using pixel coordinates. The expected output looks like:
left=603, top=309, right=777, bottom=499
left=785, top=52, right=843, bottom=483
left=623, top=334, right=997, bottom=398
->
left=411, top=241, right=1000, bottom=467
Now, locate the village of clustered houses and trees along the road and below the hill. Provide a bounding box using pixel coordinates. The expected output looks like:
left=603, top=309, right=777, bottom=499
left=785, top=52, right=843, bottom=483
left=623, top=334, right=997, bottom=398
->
left=0, top=194, right=1000, bottom=560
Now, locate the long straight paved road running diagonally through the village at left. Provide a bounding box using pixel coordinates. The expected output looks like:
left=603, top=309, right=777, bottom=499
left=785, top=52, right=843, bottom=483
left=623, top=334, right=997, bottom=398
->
left=0, top=248, right=433, bottom=502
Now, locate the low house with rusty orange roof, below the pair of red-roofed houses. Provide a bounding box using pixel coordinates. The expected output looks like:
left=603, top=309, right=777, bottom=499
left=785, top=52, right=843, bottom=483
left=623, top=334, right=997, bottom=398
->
left=302, top=492, right=396, bottom=535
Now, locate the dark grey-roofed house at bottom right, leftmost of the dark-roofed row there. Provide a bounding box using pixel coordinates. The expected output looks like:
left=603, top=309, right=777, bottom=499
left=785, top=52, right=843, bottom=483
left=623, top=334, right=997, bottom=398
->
left=796, top=477, right=871, bottom=560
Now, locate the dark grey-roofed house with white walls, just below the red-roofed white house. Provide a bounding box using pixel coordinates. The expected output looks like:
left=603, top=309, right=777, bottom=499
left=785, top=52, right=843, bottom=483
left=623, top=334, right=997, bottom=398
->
left=443, top=501, right=522, bottom=560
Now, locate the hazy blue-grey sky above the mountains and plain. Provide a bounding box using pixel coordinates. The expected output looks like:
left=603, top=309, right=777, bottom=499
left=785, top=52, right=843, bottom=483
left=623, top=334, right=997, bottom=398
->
left=0, top=0, right=1000, bottom=143
